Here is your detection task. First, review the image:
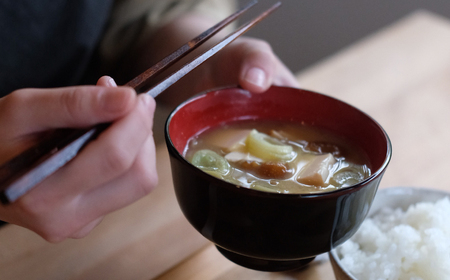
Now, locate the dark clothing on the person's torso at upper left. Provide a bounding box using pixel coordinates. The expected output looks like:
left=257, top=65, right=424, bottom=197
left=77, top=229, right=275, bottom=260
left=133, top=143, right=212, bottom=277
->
left=0, top=0, right=113, bottom=97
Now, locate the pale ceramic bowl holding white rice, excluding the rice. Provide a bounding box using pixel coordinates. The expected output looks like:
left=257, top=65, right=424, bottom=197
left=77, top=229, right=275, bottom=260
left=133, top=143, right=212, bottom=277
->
left=329, top=187, right=450, bottom=280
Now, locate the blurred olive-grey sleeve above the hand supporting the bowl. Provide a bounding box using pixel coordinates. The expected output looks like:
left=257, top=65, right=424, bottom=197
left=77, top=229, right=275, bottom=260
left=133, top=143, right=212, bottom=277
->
left=99, top=0, right=237, bottom=63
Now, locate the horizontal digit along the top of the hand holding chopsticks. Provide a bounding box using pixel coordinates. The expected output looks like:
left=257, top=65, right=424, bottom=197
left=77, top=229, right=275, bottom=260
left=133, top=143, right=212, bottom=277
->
left=0, top=86, right=136, bottom=135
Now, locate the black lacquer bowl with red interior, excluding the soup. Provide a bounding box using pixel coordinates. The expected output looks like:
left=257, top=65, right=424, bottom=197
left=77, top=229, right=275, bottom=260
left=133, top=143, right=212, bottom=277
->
left=165, top=86, right=391, bottom=271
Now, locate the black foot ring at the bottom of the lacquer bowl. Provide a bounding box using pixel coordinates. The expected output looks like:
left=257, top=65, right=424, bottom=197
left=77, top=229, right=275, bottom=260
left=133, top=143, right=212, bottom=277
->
left=216, top=246, right=315, bottom=271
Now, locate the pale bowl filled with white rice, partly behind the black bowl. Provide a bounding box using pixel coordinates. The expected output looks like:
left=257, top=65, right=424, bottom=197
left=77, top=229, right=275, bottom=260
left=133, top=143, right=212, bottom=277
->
left=329, top=187, right=450, bottom=280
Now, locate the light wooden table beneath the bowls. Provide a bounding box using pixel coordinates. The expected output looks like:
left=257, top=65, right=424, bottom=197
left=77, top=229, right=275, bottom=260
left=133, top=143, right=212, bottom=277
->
left=0, top=11, right=450, bottom=280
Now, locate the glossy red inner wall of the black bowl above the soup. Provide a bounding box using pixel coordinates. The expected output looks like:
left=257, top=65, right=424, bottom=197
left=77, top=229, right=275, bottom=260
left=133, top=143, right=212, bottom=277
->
left=166, top=86, right=390, bottom=176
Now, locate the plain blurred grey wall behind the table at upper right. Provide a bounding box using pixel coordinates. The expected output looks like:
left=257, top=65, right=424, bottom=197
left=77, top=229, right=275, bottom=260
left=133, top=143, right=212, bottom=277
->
left=239, top=0, right=450, bottom=72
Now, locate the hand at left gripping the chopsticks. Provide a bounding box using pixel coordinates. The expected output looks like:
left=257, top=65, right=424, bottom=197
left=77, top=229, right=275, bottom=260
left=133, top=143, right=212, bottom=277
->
left=0, top=77, right=157, bottom=242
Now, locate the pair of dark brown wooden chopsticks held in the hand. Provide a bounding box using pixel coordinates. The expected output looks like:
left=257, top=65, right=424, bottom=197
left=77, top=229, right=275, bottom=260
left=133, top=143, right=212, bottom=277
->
left=0, top=1, right=281, bottom=204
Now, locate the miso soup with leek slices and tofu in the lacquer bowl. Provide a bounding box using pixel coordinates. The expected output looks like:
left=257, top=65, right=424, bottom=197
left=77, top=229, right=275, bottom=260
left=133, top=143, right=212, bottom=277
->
left=184, top=121, right=371, bottom=193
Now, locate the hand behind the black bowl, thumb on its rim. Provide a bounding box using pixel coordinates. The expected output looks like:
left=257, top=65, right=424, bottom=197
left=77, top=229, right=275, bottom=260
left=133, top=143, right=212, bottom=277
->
left=156, top=37, right=299, bottom=105
